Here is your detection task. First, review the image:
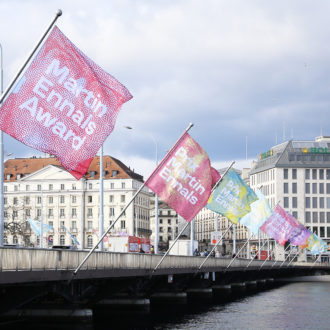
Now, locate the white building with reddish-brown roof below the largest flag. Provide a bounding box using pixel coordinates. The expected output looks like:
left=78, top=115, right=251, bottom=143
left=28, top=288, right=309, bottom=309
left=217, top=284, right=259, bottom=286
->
left=4, top=156, right=151, bottom=250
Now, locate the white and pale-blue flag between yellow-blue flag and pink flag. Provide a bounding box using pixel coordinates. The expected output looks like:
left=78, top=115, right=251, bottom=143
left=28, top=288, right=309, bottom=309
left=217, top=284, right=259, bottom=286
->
left=239, top=190, right=273, bottom=235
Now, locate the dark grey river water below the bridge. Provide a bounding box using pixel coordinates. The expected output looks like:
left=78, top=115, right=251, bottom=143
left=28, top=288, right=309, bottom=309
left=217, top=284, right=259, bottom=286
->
left=1, top=282, right=330, bottom=330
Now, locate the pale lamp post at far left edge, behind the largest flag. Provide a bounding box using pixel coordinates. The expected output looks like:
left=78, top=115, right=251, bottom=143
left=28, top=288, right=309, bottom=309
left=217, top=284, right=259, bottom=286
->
left=0, top=43, right=5, bottom=246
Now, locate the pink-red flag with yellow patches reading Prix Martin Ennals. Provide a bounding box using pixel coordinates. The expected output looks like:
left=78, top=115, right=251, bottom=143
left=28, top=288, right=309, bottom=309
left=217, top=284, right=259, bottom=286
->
left=145, top=133, right=220, bottom=221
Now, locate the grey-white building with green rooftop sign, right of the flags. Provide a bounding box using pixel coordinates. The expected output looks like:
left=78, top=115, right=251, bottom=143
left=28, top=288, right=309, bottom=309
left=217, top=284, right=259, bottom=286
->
left=250, top=136, right=330, bottom=248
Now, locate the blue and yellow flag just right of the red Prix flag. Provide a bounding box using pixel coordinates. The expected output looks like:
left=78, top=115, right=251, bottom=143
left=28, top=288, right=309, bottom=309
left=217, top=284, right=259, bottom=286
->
left=206, top=169, right=258, bottom=223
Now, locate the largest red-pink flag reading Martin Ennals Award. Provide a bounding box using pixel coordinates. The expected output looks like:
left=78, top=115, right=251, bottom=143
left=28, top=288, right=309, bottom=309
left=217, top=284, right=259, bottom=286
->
left=0, top=27, right=132, bottom=179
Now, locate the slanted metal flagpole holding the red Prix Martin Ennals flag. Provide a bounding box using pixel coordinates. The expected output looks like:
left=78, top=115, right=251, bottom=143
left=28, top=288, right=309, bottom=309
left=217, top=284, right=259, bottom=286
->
left=73, top=123, right=194, bottom=275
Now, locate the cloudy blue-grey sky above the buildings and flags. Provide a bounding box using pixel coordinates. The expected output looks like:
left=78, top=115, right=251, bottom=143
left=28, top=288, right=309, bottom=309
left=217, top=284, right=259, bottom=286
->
left=0, top=0, right=330, bottom=178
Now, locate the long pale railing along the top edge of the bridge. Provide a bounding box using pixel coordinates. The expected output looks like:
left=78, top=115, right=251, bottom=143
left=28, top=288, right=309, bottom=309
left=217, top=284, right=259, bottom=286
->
left=0, top=248, right=328, bottom=272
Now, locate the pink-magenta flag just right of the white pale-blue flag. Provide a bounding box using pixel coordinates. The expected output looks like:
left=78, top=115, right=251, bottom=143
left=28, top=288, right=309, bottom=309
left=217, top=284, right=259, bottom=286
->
left=260, top=205, right=301, bottom=245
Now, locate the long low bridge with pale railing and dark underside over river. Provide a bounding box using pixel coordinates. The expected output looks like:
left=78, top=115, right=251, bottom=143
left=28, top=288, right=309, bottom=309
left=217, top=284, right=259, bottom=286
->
left=0, top=248, right=330, bottom=316
